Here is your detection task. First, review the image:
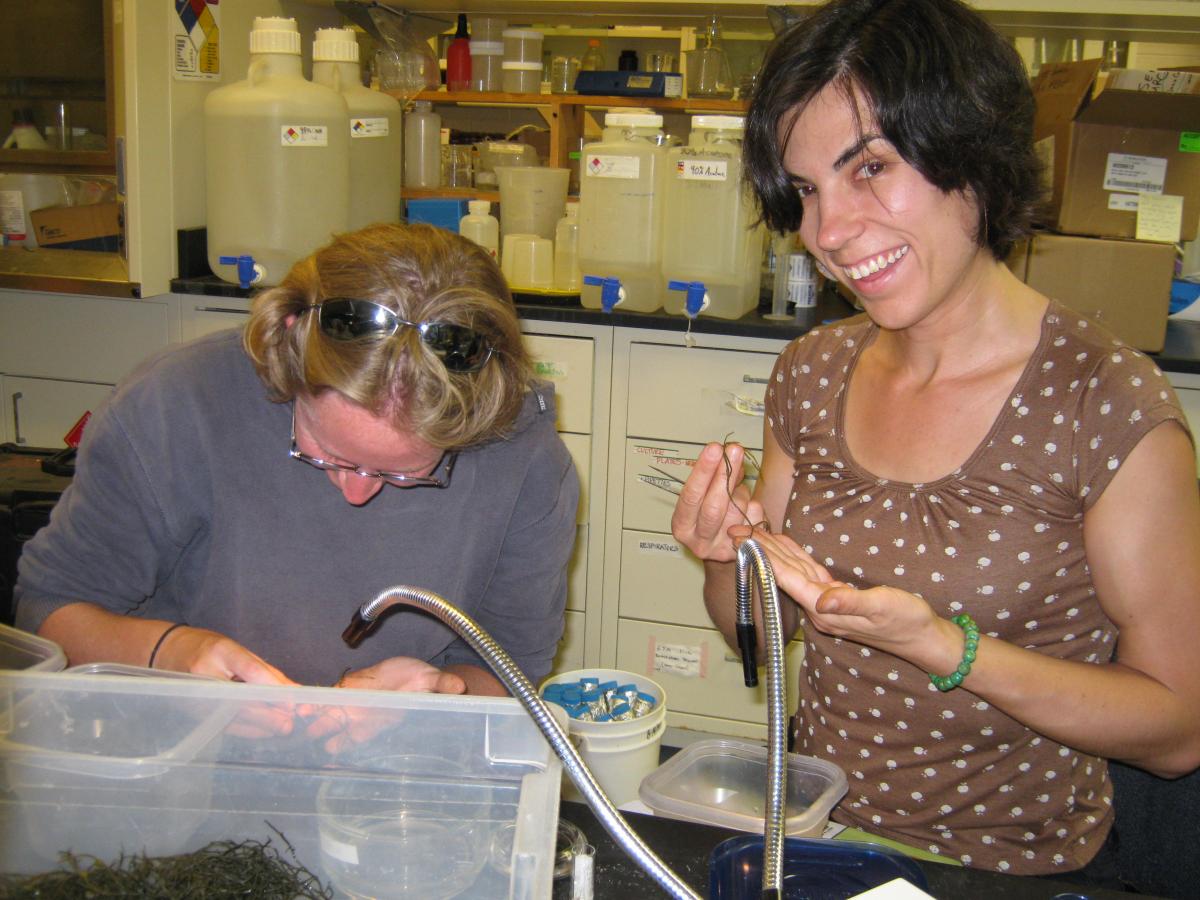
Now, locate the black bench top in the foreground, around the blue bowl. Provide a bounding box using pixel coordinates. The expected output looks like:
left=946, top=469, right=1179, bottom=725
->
left=554, top=800, right=1145, bottom=900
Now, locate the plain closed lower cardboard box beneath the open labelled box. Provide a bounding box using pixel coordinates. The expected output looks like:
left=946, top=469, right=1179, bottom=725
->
left=1025, top=234, right=1175, bottom=353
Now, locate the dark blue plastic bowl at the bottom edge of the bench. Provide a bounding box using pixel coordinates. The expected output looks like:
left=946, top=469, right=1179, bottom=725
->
left=708, top=834, right=929, bottom=900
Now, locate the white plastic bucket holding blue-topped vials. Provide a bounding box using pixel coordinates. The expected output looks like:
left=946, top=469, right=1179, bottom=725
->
left=541, top=668, right=667, bottom=806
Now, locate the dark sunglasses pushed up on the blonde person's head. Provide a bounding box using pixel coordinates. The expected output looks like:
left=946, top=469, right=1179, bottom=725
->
left=304, top=298, right=492, bottom=373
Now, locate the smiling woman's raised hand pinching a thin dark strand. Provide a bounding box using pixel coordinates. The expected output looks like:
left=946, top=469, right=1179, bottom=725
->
left=671, top=442, right=766, bottom=563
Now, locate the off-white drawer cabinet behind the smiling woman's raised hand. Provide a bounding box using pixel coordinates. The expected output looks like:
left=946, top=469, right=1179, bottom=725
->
left=605, top=329, right=803, bottom=737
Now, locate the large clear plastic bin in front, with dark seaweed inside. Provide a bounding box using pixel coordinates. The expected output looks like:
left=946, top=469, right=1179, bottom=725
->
left=0, top=672, right=562, bottom=900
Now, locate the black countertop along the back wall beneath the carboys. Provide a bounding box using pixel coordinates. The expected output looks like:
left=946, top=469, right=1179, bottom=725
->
left=170, top=275, right=1200, bottom=373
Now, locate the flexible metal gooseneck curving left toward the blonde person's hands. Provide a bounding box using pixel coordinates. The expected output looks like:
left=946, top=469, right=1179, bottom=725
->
left=342, top=586, right=700, bottom=900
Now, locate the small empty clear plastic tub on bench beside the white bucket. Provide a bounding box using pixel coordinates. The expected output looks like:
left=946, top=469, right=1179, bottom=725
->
left=638, top=738, right=847, bottom=838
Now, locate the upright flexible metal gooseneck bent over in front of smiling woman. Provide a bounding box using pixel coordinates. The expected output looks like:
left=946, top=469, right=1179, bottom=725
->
left=734, top=538, right=787, bottom=900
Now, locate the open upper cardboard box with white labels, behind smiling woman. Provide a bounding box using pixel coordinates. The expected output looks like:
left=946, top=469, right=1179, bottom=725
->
left=1033, top=60, right=1200, bottom=240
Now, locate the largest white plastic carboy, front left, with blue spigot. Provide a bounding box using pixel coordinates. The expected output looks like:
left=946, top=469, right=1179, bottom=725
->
left=204, top=17, right=350, bottom=287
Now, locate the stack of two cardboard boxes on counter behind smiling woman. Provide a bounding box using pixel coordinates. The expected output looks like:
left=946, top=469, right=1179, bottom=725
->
left=1010, top=60, right=1200, bottom=353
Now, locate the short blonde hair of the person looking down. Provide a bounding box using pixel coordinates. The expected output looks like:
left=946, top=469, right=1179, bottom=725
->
left=242, top=224, right=533, bottom=449
